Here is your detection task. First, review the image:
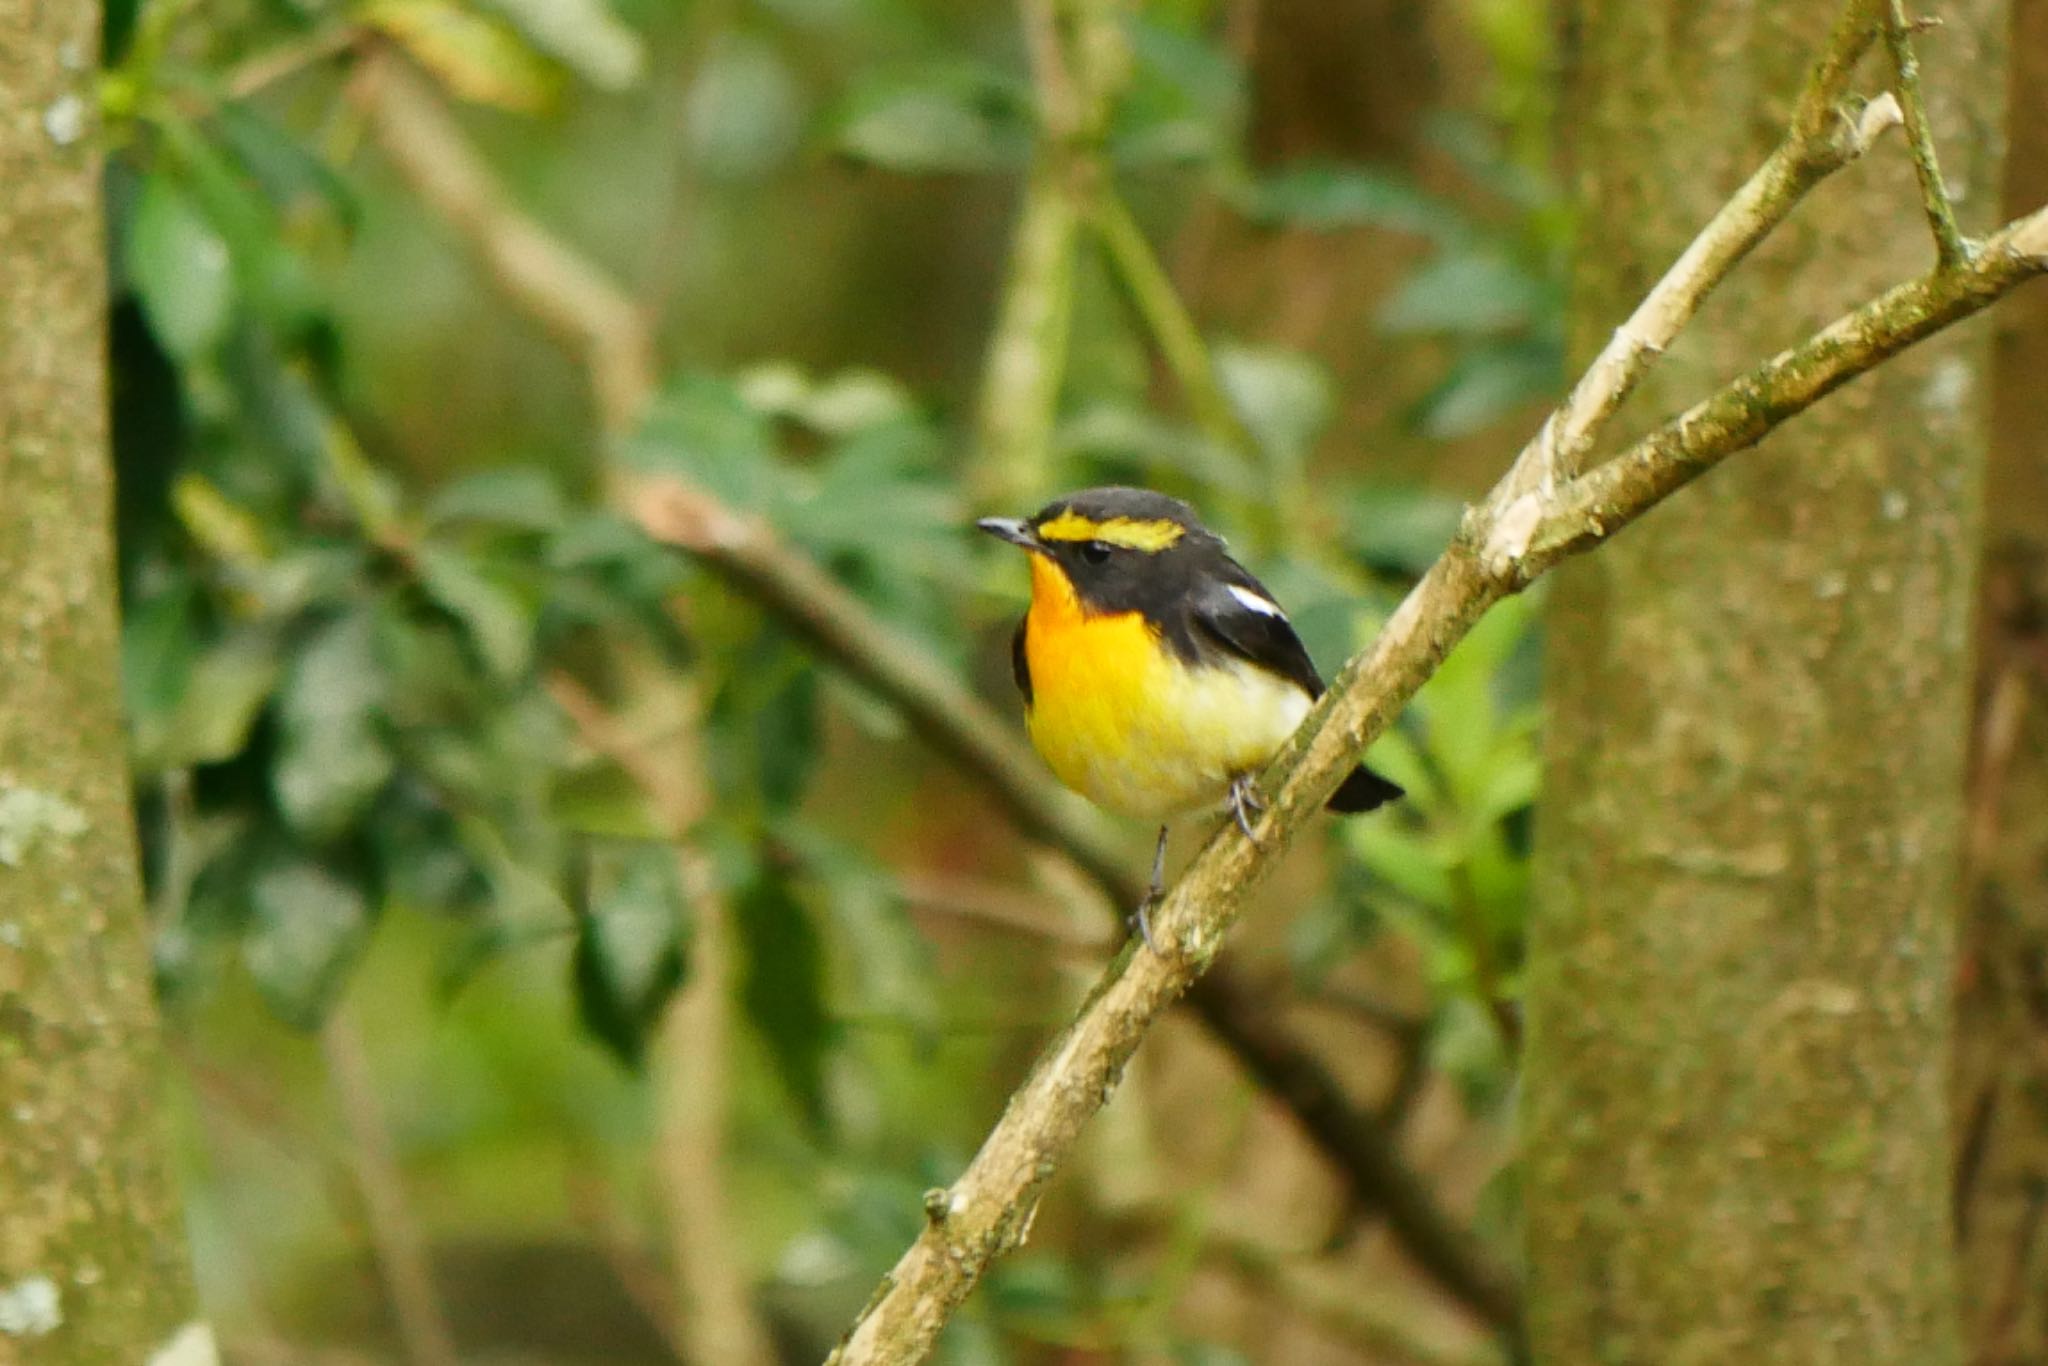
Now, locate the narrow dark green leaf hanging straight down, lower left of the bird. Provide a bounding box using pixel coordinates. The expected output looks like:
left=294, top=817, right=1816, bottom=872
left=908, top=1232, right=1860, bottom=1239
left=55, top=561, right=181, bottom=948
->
left=733, top=872, right=834, bottom=1130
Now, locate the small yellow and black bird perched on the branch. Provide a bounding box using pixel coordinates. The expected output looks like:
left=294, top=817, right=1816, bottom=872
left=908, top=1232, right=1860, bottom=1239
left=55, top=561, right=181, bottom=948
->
left=977, top=487, right=1401, bottom=942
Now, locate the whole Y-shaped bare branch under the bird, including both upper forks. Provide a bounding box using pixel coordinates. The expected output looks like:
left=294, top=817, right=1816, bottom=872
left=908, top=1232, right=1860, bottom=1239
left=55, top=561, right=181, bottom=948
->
left=831, top=13, right=2048, bottom=1366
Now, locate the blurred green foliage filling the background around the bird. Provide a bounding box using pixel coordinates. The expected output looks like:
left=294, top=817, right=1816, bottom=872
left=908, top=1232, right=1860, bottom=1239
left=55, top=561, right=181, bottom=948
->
left=104, top=0, right=1561, bottom=1366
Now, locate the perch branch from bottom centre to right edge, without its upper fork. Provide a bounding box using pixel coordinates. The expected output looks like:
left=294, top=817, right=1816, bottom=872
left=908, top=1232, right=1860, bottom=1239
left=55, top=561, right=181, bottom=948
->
left=831, top=109, right=2048, bottom=1366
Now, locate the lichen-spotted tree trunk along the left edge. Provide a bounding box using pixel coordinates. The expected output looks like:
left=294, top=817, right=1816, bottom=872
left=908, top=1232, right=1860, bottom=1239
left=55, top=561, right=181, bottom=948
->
left=0, top=0, right=201, bottom=1366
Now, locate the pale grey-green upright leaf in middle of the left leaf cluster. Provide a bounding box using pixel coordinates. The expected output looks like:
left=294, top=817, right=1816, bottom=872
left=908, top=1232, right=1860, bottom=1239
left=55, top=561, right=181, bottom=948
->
left=270, top=612, right=395, bottom=844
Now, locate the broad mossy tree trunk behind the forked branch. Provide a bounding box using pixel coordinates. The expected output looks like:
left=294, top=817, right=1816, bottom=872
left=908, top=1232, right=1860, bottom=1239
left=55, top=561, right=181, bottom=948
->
left=1524, top=0, right=2005, bottom=1366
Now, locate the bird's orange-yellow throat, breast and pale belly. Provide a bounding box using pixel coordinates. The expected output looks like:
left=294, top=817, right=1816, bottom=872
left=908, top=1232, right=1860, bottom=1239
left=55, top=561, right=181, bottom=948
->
left=1024, top=555, right=1309, bottom=821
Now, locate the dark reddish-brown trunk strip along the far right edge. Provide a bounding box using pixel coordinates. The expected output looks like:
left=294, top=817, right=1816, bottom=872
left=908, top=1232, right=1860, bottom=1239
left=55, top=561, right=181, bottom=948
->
left=1954, top=0, right=2048, bottom=1366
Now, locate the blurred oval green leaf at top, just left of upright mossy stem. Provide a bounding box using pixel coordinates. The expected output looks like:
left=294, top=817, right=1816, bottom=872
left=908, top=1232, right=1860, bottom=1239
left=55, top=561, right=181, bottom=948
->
left=836, top=61, right=1032, bottom=174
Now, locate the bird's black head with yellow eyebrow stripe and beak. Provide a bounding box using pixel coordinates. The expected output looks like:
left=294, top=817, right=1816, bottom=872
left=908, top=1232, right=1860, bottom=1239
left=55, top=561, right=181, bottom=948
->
left=977, top=487, right=1223, bottom=621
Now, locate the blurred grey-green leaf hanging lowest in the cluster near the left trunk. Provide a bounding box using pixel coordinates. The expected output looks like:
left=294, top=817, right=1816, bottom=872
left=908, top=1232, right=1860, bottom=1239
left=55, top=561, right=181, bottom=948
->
left=242, top=862, right=371, bottom=1030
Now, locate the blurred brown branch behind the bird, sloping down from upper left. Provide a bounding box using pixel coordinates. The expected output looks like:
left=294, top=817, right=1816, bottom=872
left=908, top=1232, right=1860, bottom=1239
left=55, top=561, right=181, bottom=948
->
left=352, top=42, right=1518, bottom=1325
